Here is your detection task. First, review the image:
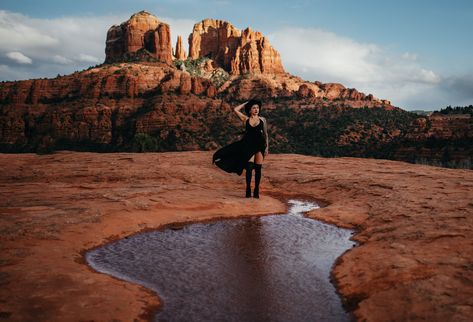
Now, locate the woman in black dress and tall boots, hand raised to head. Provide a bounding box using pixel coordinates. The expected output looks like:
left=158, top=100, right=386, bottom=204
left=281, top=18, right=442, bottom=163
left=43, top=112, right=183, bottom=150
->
left=213, top=99, right=269, bottom=198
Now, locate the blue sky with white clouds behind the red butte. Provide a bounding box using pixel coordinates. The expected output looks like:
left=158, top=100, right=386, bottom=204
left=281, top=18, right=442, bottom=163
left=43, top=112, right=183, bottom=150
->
left=0, top=0, right=473, bottom=110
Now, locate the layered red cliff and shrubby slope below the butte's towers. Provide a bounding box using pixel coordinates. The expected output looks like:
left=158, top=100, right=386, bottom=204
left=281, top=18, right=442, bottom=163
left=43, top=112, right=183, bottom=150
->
left=0, top=62, right=473, bottom=167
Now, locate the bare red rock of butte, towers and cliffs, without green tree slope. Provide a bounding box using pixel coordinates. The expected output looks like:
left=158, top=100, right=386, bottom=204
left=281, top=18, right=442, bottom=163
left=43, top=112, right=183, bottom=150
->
left=0, top=11, right=396, bottom=150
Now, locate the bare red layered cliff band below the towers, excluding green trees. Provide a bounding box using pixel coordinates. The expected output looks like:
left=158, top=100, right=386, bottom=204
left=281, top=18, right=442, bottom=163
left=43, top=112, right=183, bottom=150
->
left=0, top=62, right=394, bottom=151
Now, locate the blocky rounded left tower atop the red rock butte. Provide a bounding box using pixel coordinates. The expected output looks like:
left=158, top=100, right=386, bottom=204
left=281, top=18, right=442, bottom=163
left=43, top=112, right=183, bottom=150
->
left=105, top=11, right=172, bottom=64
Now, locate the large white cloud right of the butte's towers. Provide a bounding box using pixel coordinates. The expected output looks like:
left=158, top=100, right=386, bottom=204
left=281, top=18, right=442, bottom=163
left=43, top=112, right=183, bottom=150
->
left=271, top=28, right=442, bottom=108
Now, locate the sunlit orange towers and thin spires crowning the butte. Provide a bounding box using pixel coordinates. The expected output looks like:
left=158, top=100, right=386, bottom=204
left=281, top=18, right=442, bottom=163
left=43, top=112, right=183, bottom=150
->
left=105, top=11, right=285, bottom=75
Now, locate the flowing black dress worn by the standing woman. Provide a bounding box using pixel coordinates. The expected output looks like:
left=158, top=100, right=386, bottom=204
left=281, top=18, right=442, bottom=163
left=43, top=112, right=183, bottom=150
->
left=212, top=118, right=266, bottom=175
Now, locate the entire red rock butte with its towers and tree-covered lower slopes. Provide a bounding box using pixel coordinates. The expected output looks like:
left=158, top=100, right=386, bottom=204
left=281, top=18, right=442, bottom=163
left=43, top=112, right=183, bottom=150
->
left=0, top=12, right=473, bottom=168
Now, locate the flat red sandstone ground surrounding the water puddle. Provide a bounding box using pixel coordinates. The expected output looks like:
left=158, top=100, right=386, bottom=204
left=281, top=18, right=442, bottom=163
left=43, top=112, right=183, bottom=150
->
left=0, top=151, right=473, bottom=322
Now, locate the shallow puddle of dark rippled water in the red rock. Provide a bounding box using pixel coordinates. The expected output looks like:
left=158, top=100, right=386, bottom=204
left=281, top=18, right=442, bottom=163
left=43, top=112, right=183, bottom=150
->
left=86, top=200, right=354, bottom=322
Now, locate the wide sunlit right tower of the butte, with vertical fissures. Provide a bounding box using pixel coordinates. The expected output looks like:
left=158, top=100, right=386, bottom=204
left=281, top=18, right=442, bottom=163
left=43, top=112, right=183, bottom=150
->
left=189, top=19, right=285, bottom=75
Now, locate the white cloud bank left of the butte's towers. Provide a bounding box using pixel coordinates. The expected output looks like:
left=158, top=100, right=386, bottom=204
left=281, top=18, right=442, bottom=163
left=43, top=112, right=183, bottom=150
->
left=0, top=10, right=129, bottom=80
